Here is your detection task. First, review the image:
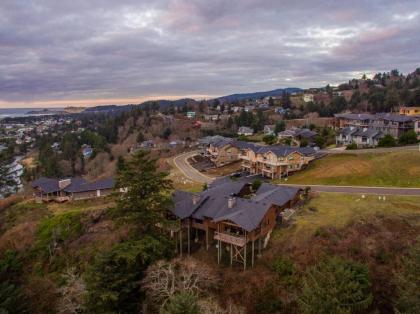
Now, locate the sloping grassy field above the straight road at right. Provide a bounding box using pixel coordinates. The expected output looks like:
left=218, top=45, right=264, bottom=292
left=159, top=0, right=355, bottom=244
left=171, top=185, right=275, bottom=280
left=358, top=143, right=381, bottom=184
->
left=282, top=151, right=420, bottom=187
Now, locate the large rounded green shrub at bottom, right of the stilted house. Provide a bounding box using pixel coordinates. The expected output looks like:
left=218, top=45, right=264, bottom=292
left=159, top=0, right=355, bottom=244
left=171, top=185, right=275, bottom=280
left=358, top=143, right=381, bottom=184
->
left=298, top=258, right=373, bottom=313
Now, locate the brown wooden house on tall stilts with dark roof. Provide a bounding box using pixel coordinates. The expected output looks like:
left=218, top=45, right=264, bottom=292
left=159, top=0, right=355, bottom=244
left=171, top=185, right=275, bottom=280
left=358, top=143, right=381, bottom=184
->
left=172, top=180, right=302, bottom=269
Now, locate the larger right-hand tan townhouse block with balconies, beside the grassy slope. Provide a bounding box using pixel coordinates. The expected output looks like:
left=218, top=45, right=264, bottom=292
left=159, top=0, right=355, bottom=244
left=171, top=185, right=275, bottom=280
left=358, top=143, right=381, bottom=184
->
left=239, top=145, right=317, bottom=179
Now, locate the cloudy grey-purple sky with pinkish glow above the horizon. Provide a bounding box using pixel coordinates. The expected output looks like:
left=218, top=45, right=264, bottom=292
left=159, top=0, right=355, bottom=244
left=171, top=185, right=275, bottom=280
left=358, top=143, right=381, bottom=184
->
left=0, top=0, right=420, bottom=107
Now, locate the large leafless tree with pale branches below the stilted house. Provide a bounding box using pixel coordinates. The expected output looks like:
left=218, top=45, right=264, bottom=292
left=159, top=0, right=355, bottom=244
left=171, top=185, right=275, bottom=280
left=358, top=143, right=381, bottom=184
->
left=142, top=258, right=219, bottom=308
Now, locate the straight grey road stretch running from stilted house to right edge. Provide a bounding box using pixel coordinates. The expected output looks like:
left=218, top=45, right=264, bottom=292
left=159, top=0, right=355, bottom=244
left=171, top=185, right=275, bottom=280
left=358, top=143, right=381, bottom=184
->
left=281, top=184, right=420, bottom=196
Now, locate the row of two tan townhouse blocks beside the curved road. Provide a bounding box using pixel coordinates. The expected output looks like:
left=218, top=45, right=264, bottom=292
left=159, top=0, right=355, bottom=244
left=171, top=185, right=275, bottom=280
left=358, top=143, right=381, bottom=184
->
left=202, top=136, right=319, bottom=179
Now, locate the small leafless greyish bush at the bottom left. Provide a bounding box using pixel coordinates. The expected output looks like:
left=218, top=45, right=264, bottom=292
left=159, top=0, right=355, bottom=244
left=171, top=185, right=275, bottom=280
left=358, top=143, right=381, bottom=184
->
left=57, top=267, right=86, bottom=314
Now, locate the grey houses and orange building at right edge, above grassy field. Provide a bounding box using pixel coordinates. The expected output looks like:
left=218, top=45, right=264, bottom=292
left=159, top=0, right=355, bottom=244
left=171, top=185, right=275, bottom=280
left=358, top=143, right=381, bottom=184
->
left=335, top=107, right=420, bottom=148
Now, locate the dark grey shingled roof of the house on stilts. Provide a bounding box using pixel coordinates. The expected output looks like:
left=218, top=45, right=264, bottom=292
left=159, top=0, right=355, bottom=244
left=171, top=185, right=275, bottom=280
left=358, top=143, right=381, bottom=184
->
left=173, top=181, right=300, bottom=231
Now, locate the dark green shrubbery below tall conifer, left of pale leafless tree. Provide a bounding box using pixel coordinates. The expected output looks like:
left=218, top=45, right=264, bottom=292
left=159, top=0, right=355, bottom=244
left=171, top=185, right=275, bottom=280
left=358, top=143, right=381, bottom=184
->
left=85, top=235, right=171, bottom=313
